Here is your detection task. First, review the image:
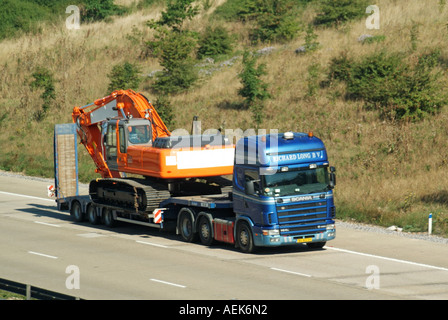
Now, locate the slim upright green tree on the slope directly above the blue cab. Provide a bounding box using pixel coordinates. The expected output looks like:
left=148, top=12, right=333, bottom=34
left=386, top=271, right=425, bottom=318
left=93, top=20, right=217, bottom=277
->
left=238, top=51, right=271, bottom=127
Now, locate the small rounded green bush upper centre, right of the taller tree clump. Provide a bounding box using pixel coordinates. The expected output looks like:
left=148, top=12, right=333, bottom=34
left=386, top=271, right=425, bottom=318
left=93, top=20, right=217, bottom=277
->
left=197, top=26, right=234, bottom=59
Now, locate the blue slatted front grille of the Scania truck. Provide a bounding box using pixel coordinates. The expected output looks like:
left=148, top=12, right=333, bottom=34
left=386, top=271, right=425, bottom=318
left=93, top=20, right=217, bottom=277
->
left=277, top=200, right=327, bottom=236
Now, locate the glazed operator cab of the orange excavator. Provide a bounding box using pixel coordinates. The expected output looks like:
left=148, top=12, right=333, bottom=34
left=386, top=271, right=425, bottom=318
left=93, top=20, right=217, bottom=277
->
left=103, top=118, right=152, bottom=170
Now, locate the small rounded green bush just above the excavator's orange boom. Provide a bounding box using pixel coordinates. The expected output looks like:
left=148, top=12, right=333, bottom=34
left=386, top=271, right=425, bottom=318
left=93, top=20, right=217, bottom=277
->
left=107, top=62, right=142, bottom=94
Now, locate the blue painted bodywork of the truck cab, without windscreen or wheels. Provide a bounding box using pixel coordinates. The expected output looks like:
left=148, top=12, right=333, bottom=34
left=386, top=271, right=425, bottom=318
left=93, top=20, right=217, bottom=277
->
left=233, top=133, right=335, bottom=246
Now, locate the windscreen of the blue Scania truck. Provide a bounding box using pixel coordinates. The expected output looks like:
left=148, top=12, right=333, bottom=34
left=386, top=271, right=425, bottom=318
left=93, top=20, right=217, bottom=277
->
left=262, top=167, right=329, bottom=197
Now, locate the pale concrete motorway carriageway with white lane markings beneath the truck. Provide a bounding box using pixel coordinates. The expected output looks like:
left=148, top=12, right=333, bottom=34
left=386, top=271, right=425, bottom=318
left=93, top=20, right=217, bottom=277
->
left=0, top=174, right=448, bottom=300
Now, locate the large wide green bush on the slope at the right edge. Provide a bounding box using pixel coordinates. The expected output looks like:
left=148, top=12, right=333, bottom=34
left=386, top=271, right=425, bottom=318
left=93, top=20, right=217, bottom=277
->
left=329, top=50, right=448, bottom=120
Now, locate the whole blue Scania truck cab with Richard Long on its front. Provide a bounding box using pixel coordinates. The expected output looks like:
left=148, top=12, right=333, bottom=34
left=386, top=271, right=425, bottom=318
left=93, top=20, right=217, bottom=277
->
left=232, top=132, right=336, bottom=252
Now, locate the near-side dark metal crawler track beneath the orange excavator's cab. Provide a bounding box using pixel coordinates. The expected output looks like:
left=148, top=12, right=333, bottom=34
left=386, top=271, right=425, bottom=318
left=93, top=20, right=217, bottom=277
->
left=89, top=178, right=171, bottom=213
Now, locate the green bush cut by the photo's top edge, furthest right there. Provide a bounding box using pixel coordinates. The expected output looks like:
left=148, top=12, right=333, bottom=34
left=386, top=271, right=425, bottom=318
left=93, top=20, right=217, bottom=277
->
left=314, top=0, right=370, bottom=26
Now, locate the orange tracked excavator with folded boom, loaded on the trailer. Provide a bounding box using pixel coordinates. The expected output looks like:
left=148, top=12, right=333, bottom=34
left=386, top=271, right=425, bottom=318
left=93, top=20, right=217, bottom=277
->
left=72, top=90, right=235, bottom=211
